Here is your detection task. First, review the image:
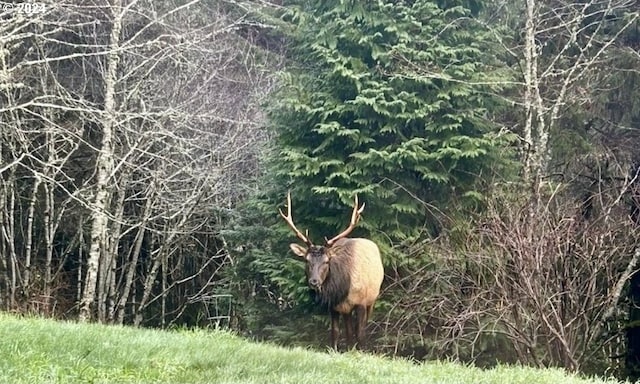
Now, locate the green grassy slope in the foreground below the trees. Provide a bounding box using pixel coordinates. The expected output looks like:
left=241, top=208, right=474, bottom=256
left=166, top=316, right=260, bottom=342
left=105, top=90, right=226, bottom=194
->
left=0, top=313, right=624, bottom=384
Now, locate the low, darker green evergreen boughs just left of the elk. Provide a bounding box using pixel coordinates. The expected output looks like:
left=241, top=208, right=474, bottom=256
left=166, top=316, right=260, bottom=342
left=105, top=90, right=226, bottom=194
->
left=222, top=167, right=327, bottom=340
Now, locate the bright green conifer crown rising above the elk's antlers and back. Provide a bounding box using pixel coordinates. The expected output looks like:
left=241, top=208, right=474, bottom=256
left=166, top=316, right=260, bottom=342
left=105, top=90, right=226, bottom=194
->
left=269, top=0, right=512, bottom=247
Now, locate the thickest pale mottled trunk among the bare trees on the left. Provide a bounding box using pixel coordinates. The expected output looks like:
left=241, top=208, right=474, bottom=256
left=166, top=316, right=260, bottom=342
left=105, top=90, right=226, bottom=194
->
left=79, top=0, right=124, bottom=322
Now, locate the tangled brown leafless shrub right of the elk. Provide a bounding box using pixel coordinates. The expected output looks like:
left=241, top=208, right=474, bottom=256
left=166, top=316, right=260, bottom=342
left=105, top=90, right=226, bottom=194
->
left=378, top=179, right=640, bottom=370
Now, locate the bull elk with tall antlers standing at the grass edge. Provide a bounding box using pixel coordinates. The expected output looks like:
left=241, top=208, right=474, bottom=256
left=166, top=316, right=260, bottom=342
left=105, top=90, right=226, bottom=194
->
left=279, top=193, right=384, bottom=350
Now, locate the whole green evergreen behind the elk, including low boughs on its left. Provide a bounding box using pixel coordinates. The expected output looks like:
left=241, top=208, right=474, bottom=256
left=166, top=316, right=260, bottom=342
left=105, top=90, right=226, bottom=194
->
left=229, top=0, right=513, bottom=358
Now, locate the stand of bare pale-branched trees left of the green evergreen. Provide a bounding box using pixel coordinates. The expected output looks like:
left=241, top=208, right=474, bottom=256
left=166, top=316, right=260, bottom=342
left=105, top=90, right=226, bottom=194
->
left=0, top=1, right=272, bottom=324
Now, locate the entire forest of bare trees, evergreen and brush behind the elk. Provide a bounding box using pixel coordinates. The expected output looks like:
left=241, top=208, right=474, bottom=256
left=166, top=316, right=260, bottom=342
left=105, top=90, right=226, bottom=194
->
left=0, top=0, right=640, bottom=379
